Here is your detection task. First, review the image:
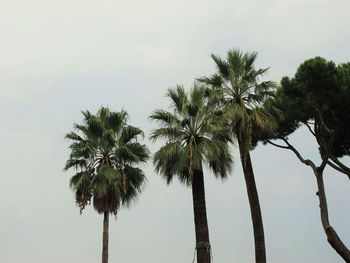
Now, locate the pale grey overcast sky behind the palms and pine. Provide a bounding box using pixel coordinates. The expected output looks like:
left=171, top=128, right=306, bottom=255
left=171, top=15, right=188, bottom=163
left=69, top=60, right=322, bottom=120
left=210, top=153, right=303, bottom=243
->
left=0, top=0, right=350, bottom=263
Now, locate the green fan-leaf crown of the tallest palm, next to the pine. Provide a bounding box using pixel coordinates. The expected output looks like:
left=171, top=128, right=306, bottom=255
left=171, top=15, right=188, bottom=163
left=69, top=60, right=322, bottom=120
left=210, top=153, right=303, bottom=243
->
left=198, top=50, right=276, bottom=151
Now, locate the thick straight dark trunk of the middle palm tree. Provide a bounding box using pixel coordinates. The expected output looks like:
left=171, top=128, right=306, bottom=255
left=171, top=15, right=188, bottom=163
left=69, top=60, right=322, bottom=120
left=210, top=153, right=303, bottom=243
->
left=192, top=170, right=211, bottom=263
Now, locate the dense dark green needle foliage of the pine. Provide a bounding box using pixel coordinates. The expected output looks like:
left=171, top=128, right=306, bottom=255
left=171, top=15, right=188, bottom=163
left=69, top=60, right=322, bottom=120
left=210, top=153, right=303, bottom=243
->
left=260, top=57, right=350, bottom=157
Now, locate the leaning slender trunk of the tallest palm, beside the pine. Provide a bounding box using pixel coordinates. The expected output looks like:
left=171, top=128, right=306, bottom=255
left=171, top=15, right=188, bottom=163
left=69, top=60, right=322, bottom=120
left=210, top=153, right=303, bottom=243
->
left=238, top=140, right=266, bottom=263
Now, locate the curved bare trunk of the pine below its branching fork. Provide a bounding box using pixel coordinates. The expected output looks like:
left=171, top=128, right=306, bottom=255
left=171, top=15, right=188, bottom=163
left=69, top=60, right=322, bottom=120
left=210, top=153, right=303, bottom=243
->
left=314, top=170, right=350, bottom=263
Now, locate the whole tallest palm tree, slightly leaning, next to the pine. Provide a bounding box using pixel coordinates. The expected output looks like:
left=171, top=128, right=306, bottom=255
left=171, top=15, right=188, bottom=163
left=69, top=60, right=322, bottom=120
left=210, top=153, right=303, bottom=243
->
left=198, top=50, right=276, bottom=263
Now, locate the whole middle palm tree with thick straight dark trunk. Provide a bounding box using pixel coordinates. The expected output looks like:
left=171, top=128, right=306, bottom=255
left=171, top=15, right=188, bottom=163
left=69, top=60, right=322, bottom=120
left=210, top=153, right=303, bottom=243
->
left=150, top=85, right=232, bottom=263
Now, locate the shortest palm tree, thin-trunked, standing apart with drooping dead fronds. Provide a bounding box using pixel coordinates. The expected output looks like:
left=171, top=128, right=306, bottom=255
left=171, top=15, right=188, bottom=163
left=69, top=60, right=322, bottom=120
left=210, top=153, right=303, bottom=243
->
left=64, top=107, right=149, bottom=263
